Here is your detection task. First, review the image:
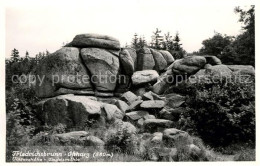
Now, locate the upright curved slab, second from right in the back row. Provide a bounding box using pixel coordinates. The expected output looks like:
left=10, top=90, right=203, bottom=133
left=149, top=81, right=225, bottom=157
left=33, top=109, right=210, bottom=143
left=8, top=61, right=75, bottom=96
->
left=150, top=49, right=167, bottom=72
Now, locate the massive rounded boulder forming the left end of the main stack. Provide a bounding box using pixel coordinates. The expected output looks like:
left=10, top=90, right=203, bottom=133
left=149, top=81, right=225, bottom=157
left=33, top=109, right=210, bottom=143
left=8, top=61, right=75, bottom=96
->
left=35, top=47, right=93, bottom=97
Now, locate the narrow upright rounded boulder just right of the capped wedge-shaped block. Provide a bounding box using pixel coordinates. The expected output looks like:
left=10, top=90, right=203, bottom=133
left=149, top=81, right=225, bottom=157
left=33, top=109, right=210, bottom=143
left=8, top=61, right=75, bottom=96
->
left=119, top=49, right=135, bottom=76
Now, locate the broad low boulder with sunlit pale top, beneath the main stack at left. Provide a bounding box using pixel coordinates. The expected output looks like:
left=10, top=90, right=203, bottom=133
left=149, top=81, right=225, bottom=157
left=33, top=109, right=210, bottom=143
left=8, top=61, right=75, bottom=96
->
left=36, top=95, right=103, bottom=127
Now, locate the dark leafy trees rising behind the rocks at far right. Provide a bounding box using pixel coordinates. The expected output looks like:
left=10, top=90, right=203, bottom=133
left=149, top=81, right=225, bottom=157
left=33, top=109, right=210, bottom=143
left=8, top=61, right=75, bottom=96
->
left=199, top=6, right=255, bottom=66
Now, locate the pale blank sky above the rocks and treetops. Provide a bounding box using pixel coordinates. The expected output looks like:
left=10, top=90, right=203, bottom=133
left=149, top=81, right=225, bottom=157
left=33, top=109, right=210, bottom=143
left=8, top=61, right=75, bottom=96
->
left=5, top=0, right=252, bottom=57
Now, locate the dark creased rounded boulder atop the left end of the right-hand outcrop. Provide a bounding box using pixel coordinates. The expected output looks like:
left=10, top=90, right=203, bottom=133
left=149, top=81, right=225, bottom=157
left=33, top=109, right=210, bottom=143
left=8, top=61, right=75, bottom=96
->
left=168, top=56, right=206, bottom=75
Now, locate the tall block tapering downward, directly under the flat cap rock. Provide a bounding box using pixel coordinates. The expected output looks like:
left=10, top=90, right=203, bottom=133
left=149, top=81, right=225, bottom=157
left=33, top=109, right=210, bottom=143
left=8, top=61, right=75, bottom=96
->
left=81, top=48, right=119, bottom=91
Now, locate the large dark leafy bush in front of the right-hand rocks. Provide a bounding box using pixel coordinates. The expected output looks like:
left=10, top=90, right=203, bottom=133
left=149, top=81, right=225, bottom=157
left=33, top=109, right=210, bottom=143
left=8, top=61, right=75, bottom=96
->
left=178, top=75, right=255, bottom=146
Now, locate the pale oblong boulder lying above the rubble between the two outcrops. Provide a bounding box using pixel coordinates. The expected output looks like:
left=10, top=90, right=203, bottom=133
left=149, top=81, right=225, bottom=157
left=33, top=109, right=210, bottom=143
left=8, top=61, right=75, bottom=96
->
left=132, top=70, right=159, bottom=85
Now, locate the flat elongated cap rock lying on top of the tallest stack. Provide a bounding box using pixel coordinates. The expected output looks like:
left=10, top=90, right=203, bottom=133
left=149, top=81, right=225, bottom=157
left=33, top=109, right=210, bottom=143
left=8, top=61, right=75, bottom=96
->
left=69, top=34, right=120, bottom=50
